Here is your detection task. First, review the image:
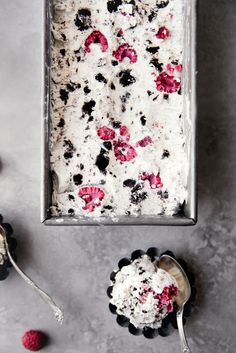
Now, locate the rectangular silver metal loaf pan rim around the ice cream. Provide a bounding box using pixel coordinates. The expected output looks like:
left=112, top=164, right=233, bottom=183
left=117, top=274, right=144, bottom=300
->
left=41, top=0, right=197, bottom=226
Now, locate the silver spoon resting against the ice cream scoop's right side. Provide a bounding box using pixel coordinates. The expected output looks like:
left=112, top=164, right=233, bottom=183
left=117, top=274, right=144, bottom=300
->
left=159, top=255, right=191, bottom=353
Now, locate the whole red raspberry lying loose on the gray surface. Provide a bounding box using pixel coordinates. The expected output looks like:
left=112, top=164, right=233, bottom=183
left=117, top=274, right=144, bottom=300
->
left=21, top=330, right=47, bottom=352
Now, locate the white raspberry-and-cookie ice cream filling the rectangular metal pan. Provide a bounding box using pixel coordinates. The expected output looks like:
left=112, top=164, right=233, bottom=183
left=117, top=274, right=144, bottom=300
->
left=50, top=0, right=188, bottom=219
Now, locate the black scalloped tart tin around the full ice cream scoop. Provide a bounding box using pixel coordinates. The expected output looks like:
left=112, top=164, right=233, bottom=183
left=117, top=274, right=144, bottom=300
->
left=107, top=247, right=197, bottom=338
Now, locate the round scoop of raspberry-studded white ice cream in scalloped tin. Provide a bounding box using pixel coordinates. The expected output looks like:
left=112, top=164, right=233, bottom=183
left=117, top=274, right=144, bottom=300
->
left=110, top=255, right=178, bottom=329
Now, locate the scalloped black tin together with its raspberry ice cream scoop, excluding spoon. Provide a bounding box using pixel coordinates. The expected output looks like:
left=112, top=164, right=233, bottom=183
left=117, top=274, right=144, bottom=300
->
left=107, top=248, right=196, bottom=338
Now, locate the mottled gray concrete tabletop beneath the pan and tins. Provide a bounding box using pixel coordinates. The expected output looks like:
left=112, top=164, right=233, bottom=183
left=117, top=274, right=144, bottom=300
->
left=0, top=0, right=236, bottom=353
